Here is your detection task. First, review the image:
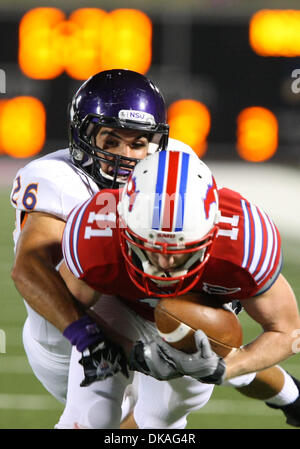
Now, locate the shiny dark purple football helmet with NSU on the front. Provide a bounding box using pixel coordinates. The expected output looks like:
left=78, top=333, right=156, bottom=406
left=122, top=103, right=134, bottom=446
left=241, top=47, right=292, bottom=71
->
left=69, top=69, right=169, bottom=188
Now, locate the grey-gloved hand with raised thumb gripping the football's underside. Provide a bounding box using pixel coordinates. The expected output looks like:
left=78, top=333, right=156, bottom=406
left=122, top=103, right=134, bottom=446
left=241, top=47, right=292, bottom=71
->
left=159, top=330, right=226, bottom=385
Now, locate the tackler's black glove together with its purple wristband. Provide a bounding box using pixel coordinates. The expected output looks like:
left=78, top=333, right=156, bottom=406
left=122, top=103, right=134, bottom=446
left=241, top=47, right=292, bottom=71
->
left=63, top=315, right=129, bottom=387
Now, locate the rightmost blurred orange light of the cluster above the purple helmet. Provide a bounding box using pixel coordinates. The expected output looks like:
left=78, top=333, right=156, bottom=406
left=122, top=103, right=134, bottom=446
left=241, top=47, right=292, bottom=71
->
left=101, top=9, right=152, bottom=74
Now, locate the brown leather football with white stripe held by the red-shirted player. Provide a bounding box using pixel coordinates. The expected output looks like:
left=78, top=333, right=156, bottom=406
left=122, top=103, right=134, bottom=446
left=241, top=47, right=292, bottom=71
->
left=154, top=293, right=243, bottom=357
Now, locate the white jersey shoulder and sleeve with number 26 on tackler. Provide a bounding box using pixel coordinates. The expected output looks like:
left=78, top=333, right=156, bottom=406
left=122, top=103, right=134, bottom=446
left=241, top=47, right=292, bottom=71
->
left=11, top=149, right=99, bottom=247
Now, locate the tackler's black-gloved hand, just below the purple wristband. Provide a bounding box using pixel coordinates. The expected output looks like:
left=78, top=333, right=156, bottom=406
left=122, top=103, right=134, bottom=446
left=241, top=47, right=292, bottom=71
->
left=79, top=340, right=129, bottom=387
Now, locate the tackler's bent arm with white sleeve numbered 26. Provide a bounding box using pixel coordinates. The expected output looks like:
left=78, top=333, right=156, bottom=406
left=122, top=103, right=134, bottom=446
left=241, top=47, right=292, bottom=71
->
left=11, top=164, right=92, bottom=331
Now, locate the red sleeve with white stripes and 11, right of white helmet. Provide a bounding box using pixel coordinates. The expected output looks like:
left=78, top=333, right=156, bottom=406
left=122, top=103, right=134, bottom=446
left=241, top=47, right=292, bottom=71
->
left=214, top=189, right=282, bottom=296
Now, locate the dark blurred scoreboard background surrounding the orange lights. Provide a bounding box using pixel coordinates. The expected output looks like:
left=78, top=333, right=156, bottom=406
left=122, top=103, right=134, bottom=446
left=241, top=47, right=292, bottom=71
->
left=0, top=5, right=300, bottom=165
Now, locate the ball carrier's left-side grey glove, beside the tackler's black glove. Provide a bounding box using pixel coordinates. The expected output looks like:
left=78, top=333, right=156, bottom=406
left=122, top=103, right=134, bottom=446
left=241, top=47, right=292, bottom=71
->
left=128, top=336, right=182, bottom=380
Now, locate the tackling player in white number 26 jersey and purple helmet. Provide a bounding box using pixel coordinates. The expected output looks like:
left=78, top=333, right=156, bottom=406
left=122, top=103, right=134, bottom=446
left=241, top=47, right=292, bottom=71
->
left=11, top=70, right=300, bottom=428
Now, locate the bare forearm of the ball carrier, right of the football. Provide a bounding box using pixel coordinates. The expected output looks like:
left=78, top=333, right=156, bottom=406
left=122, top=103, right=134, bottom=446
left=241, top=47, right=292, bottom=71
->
left=224, top=331, right=295, bottom=379
